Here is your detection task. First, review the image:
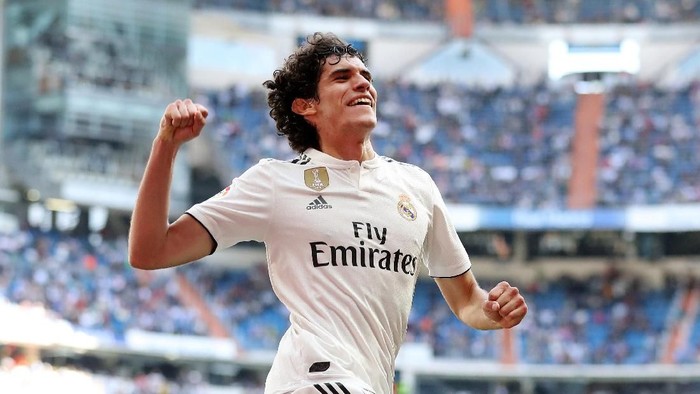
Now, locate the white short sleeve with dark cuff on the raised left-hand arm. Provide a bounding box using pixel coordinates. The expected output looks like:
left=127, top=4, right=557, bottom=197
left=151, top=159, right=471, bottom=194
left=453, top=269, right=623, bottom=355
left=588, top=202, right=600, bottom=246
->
left=187, top=161, right=275, bottom=249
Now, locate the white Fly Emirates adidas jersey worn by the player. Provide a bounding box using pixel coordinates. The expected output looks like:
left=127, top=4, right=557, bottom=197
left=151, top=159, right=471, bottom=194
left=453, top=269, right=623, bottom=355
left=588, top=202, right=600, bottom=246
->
left=188, top=149, right=471, bottom=394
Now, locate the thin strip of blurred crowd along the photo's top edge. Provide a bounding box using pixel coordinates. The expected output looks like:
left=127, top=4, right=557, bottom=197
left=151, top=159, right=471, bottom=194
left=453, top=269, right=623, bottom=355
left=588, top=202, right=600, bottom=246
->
left=194, top=0, right=700, bottom=24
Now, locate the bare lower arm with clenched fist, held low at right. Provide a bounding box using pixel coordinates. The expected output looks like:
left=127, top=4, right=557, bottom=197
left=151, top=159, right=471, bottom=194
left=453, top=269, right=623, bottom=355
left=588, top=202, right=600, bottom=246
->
left=435, top=271, right=527, bottom=330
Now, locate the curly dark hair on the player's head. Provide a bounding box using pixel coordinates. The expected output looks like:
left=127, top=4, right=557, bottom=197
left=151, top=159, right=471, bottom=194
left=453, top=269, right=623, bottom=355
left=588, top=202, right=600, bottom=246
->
left=263, top=32, right=366, bottom=153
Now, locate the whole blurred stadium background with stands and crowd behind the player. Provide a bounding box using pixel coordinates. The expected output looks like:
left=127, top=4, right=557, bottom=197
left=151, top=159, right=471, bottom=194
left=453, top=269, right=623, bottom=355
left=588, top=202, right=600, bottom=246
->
left=0, top=0, right=700, bottom=394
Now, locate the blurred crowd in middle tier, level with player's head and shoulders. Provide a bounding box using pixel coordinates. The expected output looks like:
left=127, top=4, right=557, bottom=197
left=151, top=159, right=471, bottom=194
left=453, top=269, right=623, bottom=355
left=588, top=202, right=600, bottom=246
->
left=199, top=78, right=700, bottom=208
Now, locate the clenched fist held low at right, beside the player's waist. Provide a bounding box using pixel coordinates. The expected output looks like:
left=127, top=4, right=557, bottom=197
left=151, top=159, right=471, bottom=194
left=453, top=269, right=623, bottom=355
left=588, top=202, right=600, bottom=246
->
left=482, top=281, right=527, bottom=328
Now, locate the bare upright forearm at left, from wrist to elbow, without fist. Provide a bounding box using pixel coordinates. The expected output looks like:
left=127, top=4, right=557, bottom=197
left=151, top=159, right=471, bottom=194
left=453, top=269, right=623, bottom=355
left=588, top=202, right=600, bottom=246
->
left=129, top=138, right=178, bottom=266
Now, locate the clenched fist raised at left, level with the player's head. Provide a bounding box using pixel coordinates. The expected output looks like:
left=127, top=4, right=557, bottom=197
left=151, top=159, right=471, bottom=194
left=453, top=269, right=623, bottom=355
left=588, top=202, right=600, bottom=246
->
left=158, top=99, right=209, bottom=145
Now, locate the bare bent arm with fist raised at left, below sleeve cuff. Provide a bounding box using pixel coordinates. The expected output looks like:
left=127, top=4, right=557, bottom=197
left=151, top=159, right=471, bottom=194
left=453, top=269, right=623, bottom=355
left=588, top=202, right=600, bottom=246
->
left=129, top=99, right=214, bottom=269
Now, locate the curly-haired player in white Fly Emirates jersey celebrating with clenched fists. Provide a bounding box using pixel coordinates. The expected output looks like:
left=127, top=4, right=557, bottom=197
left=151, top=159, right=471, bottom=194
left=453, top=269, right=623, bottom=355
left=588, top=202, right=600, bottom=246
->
left=129, top=33, right=527, bottom=394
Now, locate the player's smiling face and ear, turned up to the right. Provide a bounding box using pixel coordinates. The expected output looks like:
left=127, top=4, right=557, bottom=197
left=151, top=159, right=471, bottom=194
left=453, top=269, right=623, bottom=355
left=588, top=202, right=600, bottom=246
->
left=302, top=56, right=377, bottom=140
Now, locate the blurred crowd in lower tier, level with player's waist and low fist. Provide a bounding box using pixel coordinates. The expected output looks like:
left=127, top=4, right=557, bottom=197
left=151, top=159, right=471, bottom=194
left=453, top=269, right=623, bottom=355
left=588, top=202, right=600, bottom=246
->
left=0, top=230, right=700, bottom=376
